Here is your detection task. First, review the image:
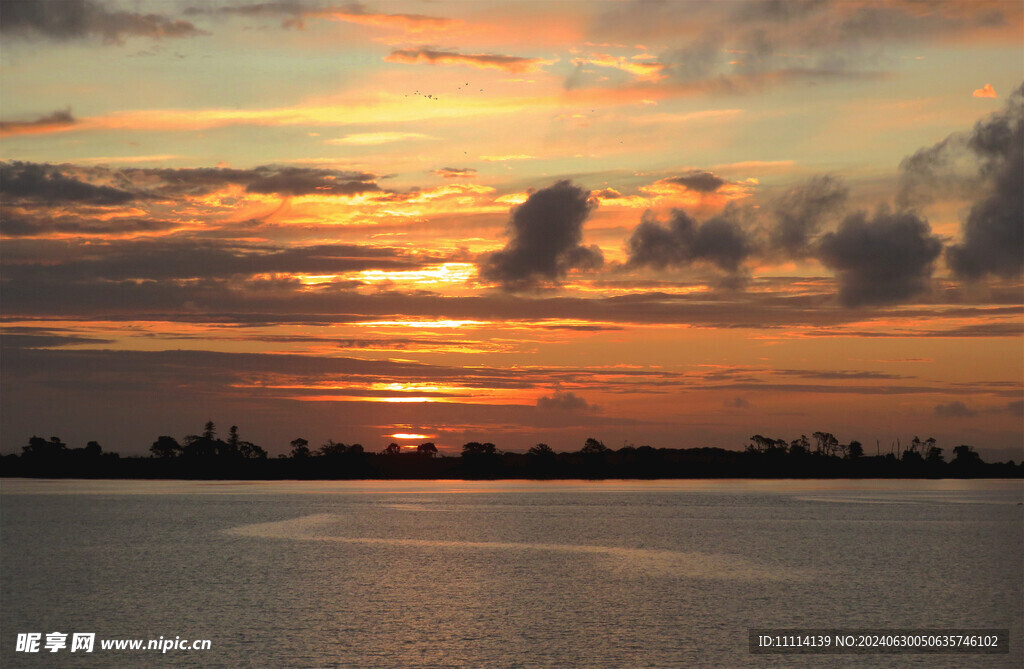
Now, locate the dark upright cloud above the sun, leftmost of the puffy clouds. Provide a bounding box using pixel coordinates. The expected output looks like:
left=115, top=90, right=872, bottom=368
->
left=480, top=181, right=604, bottom=291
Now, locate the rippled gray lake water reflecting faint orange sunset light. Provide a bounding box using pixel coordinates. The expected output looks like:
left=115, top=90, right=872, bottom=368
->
left=0, top=479, right=1024, bottom=667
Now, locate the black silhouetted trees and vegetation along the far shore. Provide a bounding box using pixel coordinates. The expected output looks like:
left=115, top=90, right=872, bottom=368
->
left=0, top=422, right=1024, bottom=480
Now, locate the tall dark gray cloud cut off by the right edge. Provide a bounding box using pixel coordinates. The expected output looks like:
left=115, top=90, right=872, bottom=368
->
left=946, top=85, right=1024, bottom=279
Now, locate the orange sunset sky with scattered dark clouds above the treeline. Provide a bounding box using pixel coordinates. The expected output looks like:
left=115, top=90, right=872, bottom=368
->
left=0, top=0, right=1024, bottom=461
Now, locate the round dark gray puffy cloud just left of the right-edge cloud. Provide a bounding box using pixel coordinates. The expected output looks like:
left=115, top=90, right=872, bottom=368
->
left=817, top=209, right=942, bottom=306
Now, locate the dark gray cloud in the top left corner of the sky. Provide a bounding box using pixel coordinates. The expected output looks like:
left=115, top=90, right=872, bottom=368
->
left=0, top=0, right=205, bottom=42
